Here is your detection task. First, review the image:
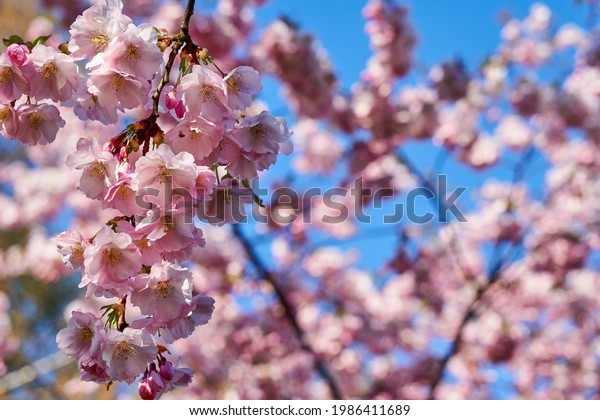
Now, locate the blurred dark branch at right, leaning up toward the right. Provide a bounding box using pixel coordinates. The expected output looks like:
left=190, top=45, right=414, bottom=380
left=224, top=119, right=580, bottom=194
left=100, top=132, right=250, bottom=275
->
left=429, top=148, right=535, bottom=399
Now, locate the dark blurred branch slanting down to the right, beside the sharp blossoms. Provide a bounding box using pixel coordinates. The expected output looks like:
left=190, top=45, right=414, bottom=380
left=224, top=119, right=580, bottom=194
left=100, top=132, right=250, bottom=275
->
left=232, top=224, right=343, bottom=400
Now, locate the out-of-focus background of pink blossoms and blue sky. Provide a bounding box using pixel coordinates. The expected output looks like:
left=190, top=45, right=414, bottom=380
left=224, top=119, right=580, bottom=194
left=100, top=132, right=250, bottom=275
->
left=0, top=0, right=600, bottom=399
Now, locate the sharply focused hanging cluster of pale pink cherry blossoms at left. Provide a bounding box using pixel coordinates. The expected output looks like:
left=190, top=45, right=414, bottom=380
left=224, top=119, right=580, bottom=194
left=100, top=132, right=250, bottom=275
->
left=12, top=0, right=291, bottom=399
